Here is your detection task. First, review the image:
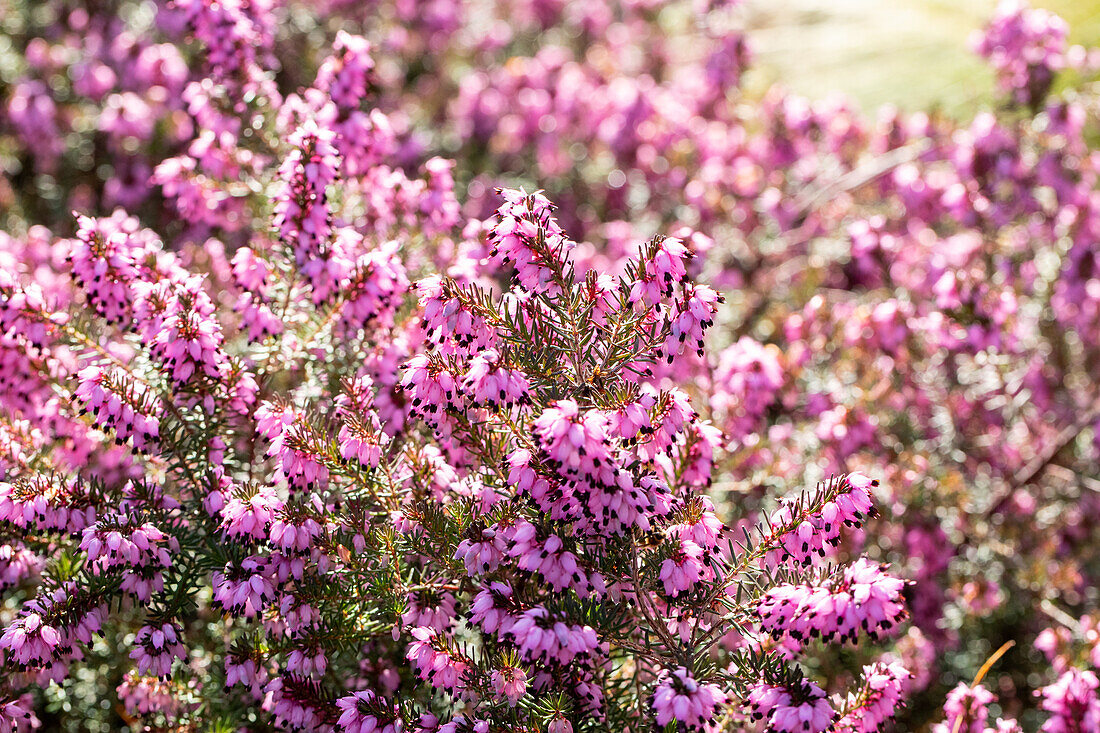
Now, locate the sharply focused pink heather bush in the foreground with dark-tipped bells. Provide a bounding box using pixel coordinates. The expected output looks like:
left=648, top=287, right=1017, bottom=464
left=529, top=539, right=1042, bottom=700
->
left=0, top=112, right=905, bottom=731
